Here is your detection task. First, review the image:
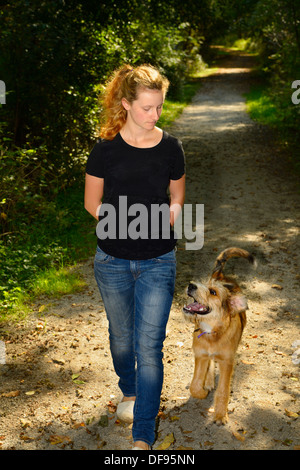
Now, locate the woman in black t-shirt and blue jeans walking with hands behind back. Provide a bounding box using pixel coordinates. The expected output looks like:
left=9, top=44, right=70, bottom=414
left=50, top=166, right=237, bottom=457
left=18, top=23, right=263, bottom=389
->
left=85, top=65, right=185, bottom=450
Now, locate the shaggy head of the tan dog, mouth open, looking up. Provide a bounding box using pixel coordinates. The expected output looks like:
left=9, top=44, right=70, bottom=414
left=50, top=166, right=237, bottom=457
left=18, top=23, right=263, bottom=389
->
left=183, top=279, right=248, bottom=328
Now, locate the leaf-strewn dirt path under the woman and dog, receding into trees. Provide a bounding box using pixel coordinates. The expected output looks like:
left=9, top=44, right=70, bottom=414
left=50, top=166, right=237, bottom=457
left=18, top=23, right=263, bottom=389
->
left=0, top=49, right=300, bottom=451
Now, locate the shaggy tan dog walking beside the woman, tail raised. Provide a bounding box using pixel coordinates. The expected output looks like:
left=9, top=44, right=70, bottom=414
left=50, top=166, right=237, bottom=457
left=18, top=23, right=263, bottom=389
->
left=183, top=248, right=254, bottom=424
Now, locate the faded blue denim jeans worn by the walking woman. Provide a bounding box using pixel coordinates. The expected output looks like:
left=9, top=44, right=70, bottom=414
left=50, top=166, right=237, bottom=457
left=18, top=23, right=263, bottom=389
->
left=94, top=247, right=176, bottom=445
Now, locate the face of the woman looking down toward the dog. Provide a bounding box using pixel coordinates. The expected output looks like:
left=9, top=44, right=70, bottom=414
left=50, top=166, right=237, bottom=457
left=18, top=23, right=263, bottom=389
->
left=122, top=88, right=164, bottom=130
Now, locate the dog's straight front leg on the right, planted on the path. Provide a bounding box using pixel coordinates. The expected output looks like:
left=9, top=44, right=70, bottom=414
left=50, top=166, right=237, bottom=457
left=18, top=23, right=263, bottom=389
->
left=214, top=361, right=233, bottom=424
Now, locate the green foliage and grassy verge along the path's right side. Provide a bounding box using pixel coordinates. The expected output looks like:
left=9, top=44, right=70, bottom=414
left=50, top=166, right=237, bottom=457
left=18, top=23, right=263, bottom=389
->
left=221, top=0, right=300, bottom=160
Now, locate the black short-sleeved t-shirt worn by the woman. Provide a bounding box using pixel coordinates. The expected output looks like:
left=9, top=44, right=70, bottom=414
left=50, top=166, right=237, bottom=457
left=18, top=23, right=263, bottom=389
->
left=86, top=131, right=185, bottom=259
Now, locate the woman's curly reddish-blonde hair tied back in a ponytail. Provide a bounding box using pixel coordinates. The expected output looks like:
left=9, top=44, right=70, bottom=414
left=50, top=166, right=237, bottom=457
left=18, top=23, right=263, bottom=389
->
left=99, top=64, right=169, bottom=140
